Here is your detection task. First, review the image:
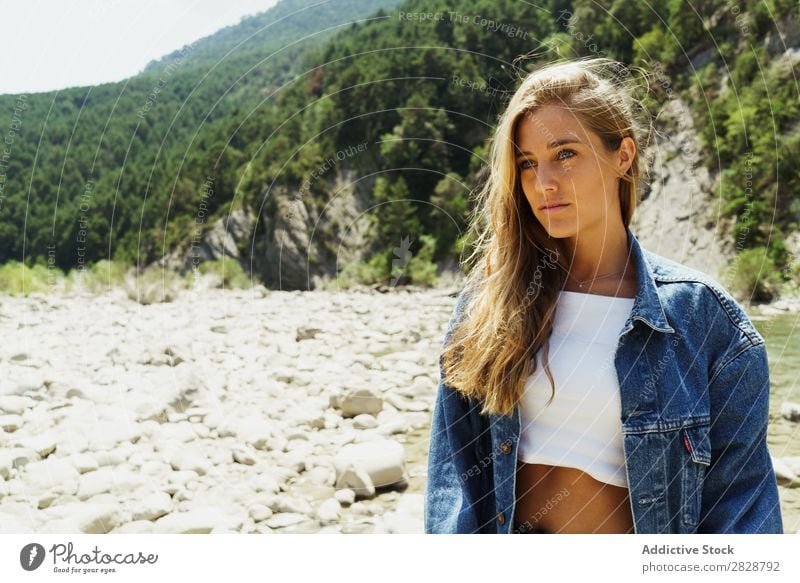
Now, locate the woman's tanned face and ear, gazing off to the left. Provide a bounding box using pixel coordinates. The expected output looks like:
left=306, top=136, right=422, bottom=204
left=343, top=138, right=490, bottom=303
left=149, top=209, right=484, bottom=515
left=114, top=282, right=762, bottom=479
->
left=514, top=105, right=636, bottom=241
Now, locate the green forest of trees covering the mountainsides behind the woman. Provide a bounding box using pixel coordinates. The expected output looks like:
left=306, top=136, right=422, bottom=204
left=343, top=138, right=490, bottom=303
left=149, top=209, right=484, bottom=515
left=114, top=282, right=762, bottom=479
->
left=0, top=0, right=800, bottom=296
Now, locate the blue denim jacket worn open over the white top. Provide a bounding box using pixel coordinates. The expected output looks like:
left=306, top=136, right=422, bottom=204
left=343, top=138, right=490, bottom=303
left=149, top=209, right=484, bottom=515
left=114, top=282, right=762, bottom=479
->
left=424, top=228, right=783, bottom=534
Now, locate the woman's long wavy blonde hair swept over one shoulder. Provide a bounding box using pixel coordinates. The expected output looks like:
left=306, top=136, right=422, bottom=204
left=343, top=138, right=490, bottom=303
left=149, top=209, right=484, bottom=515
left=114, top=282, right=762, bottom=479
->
left=440, top=57, right=652, bottom=415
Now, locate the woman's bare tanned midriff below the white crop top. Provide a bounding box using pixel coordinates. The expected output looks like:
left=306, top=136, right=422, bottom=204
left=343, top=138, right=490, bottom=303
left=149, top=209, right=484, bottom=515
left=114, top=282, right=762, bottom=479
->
left=514, top=460, right=634, bottom=534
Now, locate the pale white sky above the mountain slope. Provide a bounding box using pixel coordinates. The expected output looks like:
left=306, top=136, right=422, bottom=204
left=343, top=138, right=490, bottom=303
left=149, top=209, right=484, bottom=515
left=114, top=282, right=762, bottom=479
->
left=0, top=0, right=278, bottom=94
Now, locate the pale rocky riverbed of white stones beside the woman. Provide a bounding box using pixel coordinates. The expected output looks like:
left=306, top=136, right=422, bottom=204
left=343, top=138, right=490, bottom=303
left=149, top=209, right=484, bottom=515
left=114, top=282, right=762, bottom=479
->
left=0, top=287, right=800, bottom=533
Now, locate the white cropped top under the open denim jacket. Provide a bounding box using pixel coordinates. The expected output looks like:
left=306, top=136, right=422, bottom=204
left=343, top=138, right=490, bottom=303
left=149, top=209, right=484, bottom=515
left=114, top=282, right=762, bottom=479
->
left=517, top=291, right=634, bottom=487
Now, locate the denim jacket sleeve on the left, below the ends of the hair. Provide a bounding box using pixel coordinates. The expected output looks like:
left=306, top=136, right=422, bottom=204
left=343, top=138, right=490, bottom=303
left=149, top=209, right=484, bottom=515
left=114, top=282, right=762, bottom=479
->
left=424, top=291, right=479, bottom=534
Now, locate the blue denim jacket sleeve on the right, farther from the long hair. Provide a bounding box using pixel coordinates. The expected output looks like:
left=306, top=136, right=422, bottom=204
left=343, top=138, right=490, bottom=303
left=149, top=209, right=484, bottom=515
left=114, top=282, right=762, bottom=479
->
left=697, top=341, right=783, bottom=533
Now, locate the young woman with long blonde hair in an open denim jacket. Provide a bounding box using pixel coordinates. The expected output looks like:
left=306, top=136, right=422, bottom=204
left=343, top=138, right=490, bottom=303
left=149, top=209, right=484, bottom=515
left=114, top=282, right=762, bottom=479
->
left=425, top=58, right=782, bottom=533
